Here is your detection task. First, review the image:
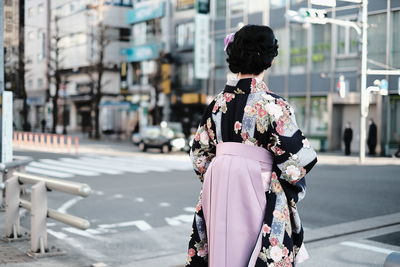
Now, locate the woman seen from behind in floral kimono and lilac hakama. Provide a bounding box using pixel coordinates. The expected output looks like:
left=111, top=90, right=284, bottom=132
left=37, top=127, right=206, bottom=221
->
left=186, top=25, right=317, bottom=267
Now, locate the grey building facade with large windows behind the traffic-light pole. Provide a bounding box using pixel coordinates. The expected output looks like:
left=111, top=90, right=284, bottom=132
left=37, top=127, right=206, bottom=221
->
left=210, top=0, right=400, bottom=154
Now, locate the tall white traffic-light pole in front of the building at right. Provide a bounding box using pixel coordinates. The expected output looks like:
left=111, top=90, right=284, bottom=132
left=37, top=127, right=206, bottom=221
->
left=359, top=0, right=369, bottom=164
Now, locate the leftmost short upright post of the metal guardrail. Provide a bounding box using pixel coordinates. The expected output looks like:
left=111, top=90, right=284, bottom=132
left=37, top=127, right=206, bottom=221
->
left=4, top=174, right=21, bottom=239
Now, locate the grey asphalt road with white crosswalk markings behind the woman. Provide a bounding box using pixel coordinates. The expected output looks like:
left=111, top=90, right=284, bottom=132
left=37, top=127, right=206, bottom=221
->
left=1, top=147, right=400, bottom=267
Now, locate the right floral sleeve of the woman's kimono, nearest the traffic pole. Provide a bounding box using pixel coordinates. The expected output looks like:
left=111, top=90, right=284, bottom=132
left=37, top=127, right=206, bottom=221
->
left=266, top=95, right=317, bottom=202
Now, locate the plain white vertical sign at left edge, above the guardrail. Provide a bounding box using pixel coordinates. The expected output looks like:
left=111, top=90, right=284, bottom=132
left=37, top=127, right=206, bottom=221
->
left=0, top=91, right=13, bottom=163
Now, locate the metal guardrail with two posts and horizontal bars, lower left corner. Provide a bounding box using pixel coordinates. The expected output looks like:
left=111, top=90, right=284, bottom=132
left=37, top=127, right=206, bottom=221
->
left=0, top=159, right=92, bottom=257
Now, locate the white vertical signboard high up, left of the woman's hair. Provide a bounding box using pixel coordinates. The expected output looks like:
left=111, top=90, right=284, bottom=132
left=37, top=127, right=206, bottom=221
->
left=194, top=13, right=210, bottom=79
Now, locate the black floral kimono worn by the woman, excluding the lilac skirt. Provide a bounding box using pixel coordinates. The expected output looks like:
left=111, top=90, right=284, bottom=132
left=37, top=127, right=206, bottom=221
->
left=186, top=78, right=317, bottom=267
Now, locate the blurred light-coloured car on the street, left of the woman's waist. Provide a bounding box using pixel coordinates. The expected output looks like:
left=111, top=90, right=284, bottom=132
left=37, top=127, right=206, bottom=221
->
left=138, top=124, right=186, bottom=153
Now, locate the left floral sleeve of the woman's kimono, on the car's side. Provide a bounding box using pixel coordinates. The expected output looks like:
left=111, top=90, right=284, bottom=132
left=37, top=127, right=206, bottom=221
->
left=190, top=101, right=216, bottom=182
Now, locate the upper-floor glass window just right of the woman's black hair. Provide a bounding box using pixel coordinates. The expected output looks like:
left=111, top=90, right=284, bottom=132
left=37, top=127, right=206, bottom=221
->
left=290, top=24, right=307, bottom=73
